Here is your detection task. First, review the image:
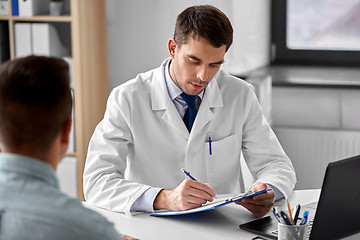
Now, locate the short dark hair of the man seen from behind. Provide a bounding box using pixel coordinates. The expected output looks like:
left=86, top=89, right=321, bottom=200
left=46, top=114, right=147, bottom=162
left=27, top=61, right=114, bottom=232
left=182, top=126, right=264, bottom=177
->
left=0, top=56, right=72, bottom=152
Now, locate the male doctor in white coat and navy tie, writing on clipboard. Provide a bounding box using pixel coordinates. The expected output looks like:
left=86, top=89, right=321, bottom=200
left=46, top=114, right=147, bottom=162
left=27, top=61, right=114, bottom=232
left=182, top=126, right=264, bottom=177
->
left=84, top=5, right=296, bottom=216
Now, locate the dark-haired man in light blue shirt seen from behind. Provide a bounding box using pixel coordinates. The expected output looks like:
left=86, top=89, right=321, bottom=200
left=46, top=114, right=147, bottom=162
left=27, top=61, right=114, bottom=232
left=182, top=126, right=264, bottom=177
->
left=0, top=56, right=134, bottom=240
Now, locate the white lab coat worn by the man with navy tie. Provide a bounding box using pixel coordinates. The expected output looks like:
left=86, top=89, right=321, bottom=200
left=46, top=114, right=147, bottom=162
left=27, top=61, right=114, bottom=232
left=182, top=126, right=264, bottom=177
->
left=84, top=59, right=296, bottom=214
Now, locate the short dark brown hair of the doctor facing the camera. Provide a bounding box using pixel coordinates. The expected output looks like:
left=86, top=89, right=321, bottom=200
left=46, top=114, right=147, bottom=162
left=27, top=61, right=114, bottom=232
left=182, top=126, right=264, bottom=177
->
left=174, top=5, right=233, bottom=51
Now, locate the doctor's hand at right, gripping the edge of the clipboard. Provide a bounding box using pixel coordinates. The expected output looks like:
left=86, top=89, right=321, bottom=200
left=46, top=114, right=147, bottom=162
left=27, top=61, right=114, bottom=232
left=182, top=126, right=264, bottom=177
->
left=235, top=182, right=275, bottom=217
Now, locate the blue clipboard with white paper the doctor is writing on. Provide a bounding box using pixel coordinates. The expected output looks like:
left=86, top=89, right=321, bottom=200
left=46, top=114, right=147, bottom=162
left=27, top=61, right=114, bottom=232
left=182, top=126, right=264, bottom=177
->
left=150, top=188, right=271, bottom=217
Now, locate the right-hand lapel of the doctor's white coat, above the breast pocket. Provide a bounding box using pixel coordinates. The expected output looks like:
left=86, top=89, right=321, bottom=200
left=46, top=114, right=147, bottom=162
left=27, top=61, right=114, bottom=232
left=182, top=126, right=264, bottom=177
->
left=191, top=77, right=223, bottom=136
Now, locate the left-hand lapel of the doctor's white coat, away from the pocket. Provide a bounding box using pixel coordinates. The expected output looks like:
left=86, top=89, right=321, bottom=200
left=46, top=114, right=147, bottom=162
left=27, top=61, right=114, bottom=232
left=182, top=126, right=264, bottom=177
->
left=151, top=59, right=189, bottom=139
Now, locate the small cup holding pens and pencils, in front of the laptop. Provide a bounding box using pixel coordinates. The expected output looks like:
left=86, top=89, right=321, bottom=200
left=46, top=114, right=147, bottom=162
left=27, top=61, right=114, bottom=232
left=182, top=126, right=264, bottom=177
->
left=278, top=223, right=309, bottom=240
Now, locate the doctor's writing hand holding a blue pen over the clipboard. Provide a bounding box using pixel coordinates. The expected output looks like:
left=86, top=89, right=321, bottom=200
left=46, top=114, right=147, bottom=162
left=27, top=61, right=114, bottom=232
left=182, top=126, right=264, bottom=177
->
left=154, top=179, right=216, bottom=211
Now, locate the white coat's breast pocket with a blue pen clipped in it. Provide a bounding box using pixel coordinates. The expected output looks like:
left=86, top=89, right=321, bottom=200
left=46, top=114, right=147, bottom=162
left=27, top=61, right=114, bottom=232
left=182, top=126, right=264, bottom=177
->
left=204, top=135, right=241, bottom=194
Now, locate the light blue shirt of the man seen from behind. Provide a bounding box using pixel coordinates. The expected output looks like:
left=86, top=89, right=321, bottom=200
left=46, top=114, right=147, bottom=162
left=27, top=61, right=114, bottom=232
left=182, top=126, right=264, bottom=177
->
left=0, top=153, right=123, bottom=240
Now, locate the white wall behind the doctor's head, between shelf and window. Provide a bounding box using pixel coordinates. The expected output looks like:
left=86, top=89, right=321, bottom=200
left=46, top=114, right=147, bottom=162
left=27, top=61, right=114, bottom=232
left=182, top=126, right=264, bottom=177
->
left=107, top=0, right=270, bottom=89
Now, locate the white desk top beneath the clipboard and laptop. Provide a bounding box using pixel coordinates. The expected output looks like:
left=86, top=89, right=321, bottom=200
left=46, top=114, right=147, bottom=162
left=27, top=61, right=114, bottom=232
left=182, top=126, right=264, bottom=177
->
left=83, top=190, right=320, bottom=240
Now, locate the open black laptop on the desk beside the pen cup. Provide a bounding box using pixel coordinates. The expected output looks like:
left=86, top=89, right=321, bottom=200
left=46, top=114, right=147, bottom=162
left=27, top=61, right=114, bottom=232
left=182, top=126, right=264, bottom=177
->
left=239, top=155, right=360, bottom=239
